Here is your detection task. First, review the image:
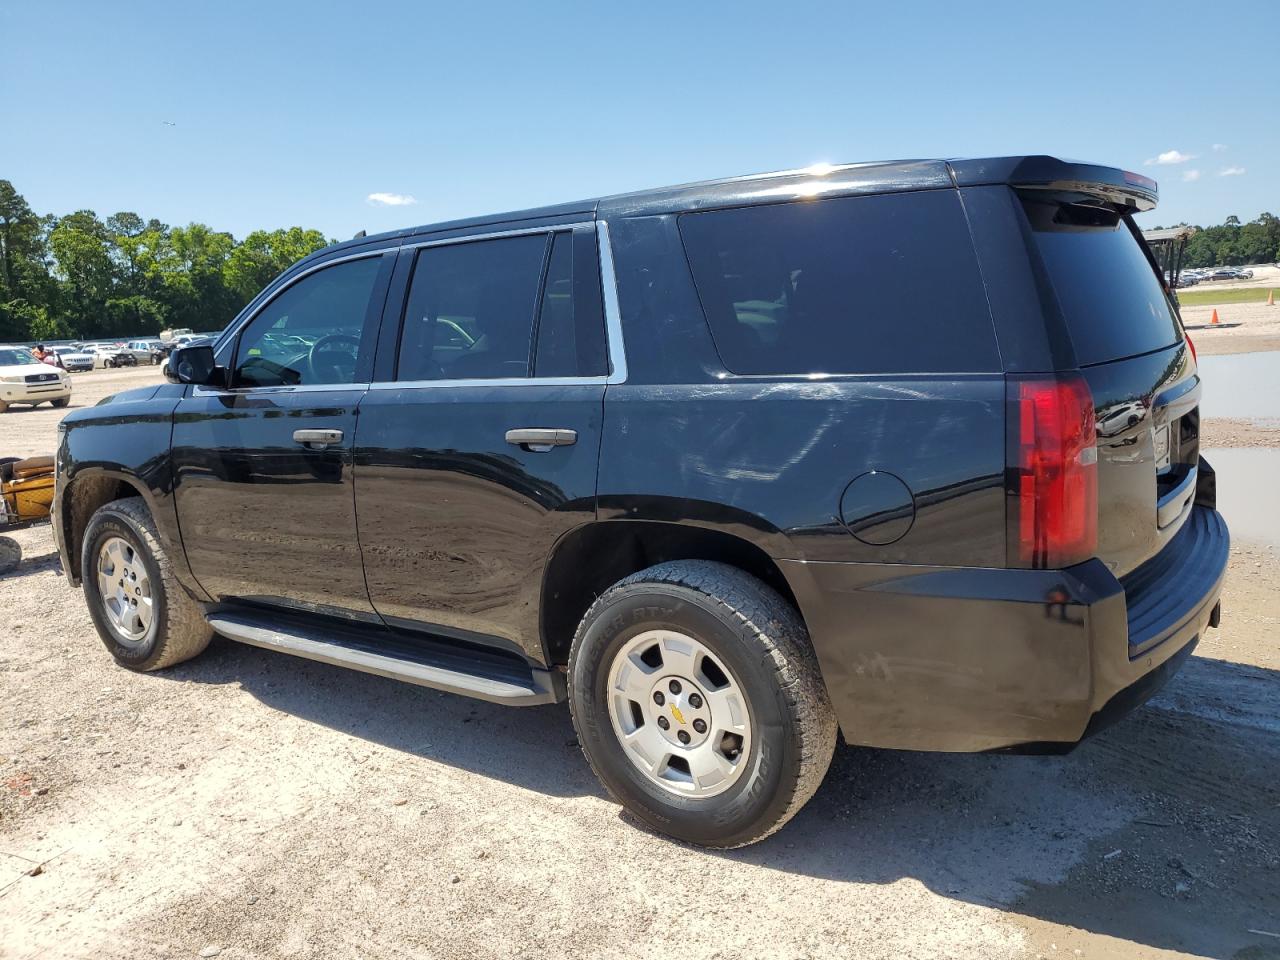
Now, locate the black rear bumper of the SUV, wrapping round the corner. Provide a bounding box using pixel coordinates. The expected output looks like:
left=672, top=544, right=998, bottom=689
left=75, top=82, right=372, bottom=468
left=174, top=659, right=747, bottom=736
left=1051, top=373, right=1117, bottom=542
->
left=780, top=506, right=1229, bottom=751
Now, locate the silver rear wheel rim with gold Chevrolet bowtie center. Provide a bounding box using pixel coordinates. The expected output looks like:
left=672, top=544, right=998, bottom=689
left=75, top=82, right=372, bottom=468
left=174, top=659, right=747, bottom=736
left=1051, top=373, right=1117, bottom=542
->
left=607, top=630, right=751, bottom=797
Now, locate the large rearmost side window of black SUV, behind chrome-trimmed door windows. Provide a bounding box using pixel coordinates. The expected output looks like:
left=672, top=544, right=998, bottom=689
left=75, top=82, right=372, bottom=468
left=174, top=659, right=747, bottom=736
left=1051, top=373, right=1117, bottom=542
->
left=680, top=191, right=1001, bottom=374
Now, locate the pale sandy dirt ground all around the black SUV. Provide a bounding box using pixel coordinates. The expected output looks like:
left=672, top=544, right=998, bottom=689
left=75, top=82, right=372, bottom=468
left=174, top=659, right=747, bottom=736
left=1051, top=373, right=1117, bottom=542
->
left=0, top=369, right=1280, bottom=960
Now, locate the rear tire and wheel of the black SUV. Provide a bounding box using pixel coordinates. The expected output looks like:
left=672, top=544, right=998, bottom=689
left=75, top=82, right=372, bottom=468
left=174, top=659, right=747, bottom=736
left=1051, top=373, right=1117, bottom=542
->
left=568, top=561, right=837, bottom=849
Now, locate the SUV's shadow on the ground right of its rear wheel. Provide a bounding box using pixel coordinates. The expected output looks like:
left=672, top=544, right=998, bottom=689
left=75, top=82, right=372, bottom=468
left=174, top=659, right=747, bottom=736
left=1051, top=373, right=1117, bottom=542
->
left=723, top=657, right=1280, bottom=957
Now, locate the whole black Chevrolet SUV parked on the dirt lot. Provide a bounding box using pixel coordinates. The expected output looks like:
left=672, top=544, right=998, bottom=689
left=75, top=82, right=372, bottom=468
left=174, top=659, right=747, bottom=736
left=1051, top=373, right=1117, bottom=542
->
left=55, top=156, right=1228, bottom=846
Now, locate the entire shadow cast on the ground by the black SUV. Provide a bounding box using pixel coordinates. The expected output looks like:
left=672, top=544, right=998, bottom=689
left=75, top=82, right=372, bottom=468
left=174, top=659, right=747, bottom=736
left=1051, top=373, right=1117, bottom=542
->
left=166, top=640, right=1280, bottom=957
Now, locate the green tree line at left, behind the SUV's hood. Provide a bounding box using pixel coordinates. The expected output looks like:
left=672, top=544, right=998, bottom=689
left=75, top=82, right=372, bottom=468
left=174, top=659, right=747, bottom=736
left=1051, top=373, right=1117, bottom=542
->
left=0, top=180, right=332, bottom=342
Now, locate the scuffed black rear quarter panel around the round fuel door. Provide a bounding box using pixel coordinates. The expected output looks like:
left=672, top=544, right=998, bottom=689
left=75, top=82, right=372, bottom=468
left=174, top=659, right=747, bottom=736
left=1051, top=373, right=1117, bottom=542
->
left=599, top=376, right=1005, bottom=566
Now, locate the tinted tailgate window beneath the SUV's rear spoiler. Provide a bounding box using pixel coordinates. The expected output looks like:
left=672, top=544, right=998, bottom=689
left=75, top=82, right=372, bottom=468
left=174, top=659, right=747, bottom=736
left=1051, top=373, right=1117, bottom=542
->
left=1023, top=200, right=1181, bottom=366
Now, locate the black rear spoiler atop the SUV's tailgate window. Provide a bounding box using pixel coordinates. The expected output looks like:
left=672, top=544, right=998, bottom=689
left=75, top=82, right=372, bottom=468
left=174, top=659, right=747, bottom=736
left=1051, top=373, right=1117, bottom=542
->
left=947, top=156, right=1160, bottom=212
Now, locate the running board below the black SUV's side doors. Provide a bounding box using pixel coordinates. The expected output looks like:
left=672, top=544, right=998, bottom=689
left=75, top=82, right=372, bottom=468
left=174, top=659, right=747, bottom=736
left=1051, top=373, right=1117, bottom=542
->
left=207, top=611, right=564, bottom=707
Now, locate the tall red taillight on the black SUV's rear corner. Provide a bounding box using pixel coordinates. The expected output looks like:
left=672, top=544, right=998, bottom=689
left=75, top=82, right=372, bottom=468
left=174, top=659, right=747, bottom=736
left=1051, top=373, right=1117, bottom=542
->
left=1007, top=374, right=1098, bottom=568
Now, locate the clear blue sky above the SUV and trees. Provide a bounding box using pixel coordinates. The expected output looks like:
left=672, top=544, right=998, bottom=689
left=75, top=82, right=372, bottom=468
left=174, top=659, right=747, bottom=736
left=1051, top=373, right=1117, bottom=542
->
left=0, top=0, right=1280, bottom=238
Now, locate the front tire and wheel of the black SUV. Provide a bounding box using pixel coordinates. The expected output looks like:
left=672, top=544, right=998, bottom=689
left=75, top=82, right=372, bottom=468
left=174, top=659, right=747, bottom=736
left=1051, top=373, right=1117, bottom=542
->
left=81, top=497, right=214, bottom=672
